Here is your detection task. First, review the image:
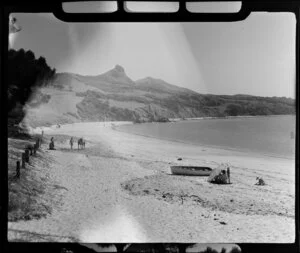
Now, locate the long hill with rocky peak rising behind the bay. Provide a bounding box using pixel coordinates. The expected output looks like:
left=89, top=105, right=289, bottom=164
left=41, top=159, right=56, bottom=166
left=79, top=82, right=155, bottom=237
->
left=22, top=65, right=295, bottom=126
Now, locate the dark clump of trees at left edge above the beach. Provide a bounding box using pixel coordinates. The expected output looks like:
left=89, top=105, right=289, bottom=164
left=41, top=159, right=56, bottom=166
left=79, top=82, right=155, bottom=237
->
left=5, top=49, right=56, bottom=136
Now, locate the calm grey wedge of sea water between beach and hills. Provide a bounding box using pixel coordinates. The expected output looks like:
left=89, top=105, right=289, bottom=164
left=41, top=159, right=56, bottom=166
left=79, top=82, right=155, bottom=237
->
left=118, top=115, right=296, bottom=158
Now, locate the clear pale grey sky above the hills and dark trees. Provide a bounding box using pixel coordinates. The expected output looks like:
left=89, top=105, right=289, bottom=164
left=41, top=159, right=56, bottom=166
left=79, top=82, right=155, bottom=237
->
left=10, top=9, right=296, bottom=98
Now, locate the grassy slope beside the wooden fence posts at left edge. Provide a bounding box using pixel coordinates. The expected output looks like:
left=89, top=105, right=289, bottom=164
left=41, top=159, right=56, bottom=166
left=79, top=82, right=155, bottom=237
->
left=8, top=134, right=53, bottom=221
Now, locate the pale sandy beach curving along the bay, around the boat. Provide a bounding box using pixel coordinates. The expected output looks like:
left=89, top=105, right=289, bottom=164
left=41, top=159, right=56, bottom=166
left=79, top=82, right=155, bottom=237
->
left=8, top=122, right=295, bottom=243
